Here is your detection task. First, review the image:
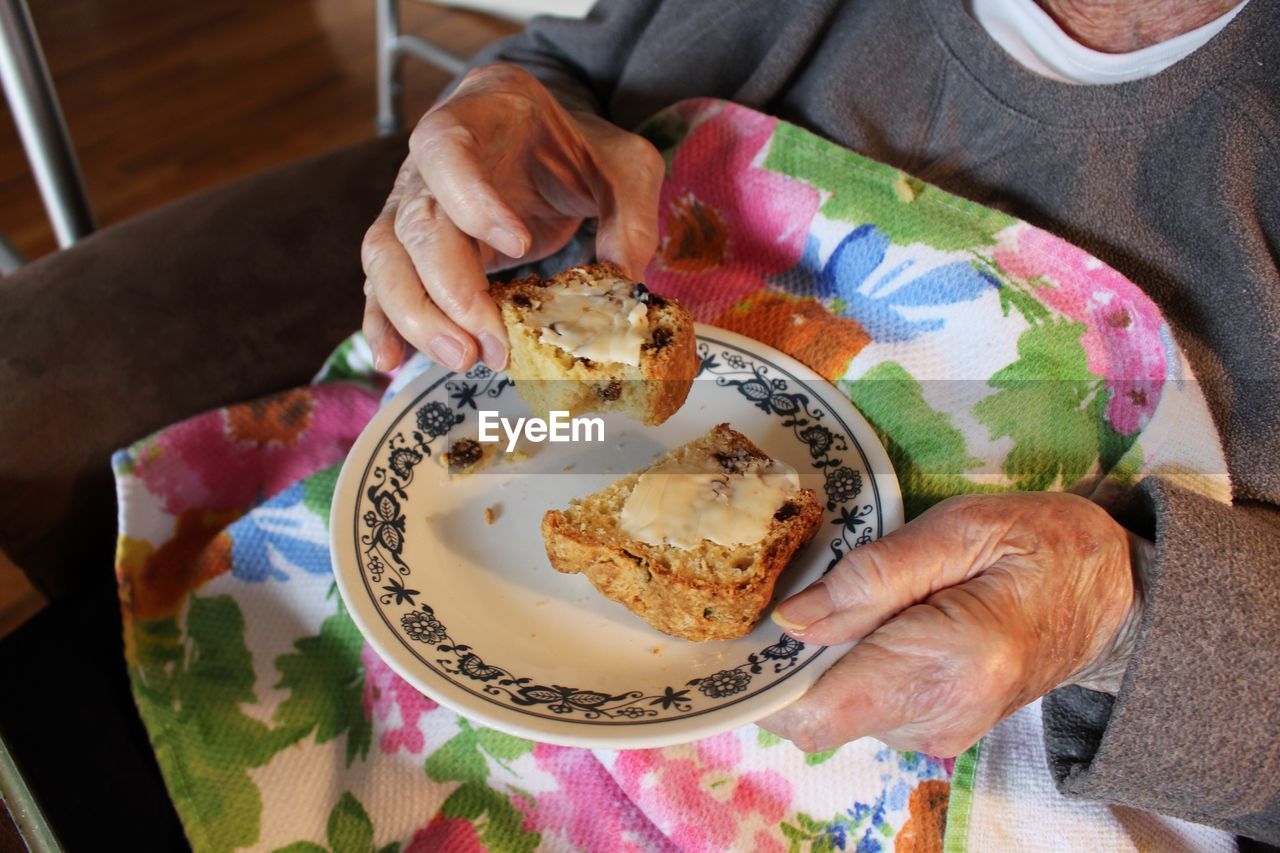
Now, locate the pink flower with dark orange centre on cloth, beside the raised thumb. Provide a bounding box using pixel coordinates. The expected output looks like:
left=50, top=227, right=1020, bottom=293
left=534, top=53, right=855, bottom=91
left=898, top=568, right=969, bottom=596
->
left=646, top=104, right=820, bottom=321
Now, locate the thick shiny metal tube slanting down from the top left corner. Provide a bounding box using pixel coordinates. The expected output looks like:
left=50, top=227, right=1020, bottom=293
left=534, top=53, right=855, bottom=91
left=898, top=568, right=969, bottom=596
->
left=0, top=0, right=95, bottom=248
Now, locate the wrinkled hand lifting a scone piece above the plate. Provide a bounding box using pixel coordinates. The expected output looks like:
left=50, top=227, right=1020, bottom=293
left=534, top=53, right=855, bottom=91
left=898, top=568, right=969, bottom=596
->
left=361, top=65, right=664, bottom=370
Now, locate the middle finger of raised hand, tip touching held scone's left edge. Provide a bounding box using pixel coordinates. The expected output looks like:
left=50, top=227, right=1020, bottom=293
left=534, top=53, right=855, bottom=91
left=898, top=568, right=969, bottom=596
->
left=396, top=192, right=507, bottom=370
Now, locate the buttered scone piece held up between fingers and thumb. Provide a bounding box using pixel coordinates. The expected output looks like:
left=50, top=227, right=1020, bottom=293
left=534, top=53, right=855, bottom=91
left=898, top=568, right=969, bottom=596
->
left=490, top=263, right=698, bottom=424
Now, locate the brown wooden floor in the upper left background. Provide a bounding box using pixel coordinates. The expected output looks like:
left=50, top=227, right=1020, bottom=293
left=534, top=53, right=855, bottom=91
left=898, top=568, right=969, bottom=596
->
left=0, top=0, right=517, bottom=259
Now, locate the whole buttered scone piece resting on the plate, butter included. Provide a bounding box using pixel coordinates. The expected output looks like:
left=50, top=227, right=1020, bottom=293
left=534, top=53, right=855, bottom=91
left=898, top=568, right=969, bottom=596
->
left=543, top=424, right=822, bottom=642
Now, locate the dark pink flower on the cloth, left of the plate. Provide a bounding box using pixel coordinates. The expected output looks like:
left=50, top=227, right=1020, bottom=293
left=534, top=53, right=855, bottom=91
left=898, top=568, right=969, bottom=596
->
left=134, top=383, right=378, bottom=515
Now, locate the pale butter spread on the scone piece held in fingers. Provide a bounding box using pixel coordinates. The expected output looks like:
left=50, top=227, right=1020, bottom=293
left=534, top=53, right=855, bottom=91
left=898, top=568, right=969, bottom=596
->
left=525, top=277, right=649, bottom=366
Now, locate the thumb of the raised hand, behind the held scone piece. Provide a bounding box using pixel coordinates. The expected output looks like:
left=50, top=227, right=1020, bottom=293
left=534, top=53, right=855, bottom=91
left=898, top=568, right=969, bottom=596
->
left=594, top=126, right=666, bottom=279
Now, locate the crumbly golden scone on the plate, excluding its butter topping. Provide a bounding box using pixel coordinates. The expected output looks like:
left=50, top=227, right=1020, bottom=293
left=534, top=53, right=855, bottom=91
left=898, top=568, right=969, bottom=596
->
left=543, top=424, right=822, bottom=642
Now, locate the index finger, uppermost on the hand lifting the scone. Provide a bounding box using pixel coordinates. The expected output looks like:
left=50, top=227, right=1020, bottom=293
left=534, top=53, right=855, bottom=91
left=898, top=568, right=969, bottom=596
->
left=410, top=109, right=532, bottom=257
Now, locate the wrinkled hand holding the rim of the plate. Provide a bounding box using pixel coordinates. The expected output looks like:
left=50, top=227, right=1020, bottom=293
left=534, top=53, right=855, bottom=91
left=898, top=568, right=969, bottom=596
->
left=760, top=493, right=1152, bottom=756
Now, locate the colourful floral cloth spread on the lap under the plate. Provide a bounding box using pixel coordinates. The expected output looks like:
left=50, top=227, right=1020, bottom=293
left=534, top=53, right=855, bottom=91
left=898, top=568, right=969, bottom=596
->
left=114, top=100, right=1231, bottom=853
